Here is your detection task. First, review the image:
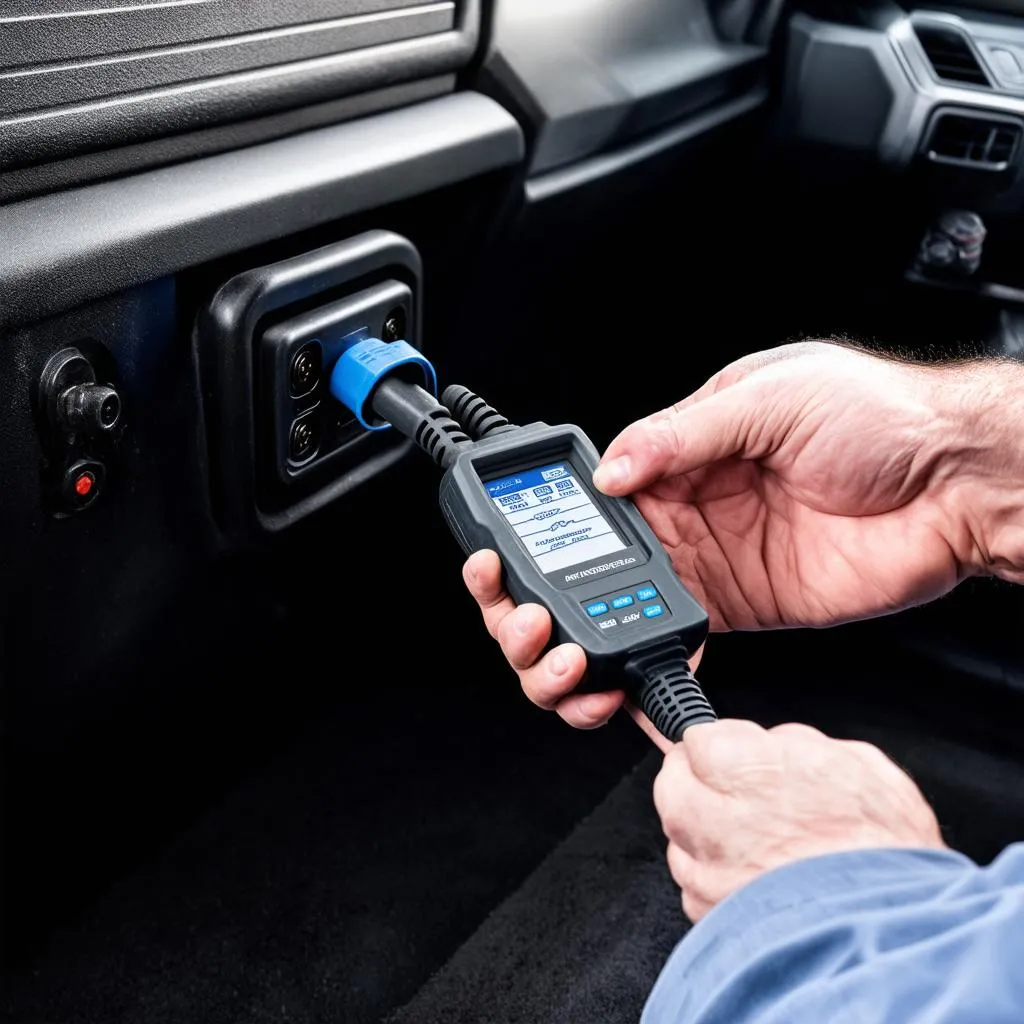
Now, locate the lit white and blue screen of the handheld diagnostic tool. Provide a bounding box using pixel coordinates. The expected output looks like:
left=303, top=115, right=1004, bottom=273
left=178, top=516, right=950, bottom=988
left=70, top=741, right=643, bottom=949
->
left=484, top=462, right=626, bottom=572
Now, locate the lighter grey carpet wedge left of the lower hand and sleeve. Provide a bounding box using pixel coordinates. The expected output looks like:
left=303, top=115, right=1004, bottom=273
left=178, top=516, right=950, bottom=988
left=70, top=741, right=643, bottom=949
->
left=388, top=754, right=688, bottom=1024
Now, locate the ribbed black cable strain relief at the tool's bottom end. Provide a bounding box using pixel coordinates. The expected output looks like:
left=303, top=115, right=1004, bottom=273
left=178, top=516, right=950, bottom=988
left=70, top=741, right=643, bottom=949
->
left=626, top=640, right=718, bottom=743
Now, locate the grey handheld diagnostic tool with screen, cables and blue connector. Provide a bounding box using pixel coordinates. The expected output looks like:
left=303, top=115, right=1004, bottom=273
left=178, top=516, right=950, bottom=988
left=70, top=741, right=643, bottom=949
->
left=332, top=342, right=715, bottom=740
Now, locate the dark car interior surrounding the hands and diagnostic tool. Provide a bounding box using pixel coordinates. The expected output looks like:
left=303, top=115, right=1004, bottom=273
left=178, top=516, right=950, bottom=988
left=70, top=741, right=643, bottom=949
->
left=6, top=0, right=1024, bottom=1024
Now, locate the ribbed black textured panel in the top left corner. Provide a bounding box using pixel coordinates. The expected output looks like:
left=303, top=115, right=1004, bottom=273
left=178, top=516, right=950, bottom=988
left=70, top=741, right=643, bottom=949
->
left=0, top=0, right=479, bottom=169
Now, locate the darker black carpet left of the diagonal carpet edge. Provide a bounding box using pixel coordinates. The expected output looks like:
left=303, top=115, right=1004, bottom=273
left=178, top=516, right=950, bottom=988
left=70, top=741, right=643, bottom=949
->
left=2, top=684, right=648, bottom=1024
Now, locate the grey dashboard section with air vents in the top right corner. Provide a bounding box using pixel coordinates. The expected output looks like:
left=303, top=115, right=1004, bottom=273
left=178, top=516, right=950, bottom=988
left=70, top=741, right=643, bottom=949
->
left=785, top=10, right=1024, bottom=180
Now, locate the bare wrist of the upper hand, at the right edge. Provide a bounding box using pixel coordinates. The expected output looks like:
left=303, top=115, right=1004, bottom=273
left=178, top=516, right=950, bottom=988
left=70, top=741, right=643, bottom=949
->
left=932, top=359, right=1024, bottom=583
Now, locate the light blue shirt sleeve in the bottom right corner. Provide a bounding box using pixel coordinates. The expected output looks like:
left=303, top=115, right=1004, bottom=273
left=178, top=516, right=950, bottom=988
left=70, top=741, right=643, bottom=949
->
left=642, top=844, right=1024, bottom=1024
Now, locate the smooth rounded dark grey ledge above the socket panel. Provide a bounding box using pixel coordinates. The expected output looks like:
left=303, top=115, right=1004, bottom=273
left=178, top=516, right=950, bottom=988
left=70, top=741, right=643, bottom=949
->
left=0, top=92, right=524, bottom=331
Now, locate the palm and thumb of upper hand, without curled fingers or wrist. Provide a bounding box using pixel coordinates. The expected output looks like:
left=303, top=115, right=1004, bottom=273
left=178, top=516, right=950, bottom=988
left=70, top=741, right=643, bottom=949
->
left=594, top=343, right=991, bottom=630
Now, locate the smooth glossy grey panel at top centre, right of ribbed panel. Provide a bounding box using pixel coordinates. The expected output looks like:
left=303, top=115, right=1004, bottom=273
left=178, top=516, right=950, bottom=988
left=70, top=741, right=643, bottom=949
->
left=484, top=0, right=766, bottom=174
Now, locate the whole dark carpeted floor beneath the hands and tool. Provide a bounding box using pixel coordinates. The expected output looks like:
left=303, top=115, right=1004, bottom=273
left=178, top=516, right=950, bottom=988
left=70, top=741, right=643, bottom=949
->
left=2, top=618, right=1024, bottom=1024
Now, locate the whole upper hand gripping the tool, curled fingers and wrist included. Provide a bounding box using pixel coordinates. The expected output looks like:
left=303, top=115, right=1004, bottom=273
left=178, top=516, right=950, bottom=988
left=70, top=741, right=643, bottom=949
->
left=465, top=342, right=1024, bottom=727
